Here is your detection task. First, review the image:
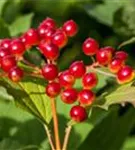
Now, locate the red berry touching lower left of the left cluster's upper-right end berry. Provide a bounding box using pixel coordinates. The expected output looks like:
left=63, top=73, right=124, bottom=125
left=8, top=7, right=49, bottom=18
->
left=52, top=29, right=68, bottom=48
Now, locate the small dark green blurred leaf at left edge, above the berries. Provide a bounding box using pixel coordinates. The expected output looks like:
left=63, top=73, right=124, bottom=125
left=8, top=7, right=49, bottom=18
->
left=0, top=18, right=10, bottom=39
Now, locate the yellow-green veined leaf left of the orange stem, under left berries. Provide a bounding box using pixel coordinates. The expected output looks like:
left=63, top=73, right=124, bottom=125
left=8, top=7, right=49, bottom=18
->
left=0, top=76, right=52, bottom=123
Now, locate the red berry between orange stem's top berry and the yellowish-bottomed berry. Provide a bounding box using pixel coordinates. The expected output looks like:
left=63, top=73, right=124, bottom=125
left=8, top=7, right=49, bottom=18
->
left=61, top=88, right=78, bottom=104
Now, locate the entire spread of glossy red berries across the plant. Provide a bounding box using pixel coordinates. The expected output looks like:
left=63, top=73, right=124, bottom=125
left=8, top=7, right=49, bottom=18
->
left=0, top=18, right=135, bottom=122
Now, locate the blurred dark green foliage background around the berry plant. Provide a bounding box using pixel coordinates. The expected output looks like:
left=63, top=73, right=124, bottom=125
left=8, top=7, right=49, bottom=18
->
left=0, top=0, right=135, bottom=150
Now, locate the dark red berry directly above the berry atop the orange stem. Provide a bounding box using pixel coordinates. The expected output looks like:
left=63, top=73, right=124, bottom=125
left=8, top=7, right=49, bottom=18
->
left=42, top=64, right=58, bottom=80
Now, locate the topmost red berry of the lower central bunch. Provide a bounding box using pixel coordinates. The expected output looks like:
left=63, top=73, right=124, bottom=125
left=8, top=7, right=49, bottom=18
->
left=69, top=61, right=86, bottom=78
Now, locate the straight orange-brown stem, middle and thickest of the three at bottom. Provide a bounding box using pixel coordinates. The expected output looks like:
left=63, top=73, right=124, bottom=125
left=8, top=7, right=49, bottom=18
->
left=50, top=98, right=61, bottom=150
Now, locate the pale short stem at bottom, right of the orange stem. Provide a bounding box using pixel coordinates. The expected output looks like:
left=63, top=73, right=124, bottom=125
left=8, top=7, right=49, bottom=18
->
left=62, top=125, right=72, bottom=150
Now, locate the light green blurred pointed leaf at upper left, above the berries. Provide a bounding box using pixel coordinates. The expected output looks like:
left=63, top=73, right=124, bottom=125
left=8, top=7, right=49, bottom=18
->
left=9, top=13, right=34, bottom=36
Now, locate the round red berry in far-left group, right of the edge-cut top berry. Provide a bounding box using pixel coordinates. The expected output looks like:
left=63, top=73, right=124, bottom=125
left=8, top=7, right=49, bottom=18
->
left=9, top=39, right=25, bottom=56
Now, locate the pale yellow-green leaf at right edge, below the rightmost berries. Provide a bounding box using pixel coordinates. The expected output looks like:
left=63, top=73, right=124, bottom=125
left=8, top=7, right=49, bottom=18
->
left=98, top=82, right=135, bottom=109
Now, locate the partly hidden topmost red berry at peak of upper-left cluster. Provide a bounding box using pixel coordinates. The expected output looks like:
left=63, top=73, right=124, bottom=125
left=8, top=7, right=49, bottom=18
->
left=40, top=17, right=56, bottom=29
